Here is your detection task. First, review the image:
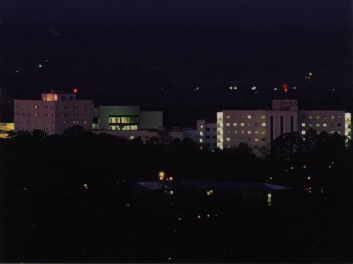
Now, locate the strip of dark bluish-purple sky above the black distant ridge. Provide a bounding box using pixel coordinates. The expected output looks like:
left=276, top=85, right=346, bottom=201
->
left=1, top=0, right=351, bottom=28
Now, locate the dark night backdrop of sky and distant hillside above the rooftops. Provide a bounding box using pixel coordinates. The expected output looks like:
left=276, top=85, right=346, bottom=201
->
left=0, top=0, right=352, bottom=126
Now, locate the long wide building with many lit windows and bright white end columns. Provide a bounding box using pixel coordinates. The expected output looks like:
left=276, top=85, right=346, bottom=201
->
left=214, top=100, right=351, bottom=149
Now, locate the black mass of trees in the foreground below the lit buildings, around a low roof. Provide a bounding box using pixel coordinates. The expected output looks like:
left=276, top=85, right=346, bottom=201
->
left=0, top=127, right=353, bottom=262
